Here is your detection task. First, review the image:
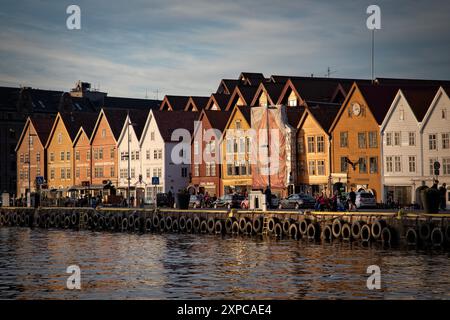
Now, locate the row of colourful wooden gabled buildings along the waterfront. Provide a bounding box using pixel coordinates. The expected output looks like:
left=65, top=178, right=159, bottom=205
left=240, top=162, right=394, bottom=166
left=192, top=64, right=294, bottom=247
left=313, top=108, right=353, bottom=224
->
left=12, top=73, right=450, bottom=208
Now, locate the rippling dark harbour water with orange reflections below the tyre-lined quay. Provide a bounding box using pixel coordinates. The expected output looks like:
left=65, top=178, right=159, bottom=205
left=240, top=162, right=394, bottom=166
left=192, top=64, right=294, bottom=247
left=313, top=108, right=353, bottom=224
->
left=0, top=228, right=450, bottom=299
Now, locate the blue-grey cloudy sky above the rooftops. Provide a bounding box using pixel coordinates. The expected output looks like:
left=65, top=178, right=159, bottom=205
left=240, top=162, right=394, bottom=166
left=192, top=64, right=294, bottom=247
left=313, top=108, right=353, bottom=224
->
left=0, top=0, right=450, bottom=99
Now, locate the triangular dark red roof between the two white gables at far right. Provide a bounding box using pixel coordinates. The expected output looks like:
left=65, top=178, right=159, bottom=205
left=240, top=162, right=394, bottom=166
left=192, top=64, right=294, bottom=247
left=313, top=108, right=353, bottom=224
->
left=401, top=86, right=439, bottom=122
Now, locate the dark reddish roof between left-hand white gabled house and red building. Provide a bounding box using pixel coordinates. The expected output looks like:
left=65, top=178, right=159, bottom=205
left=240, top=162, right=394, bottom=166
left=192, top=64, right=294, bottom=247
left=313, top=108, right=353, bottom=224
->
left=153, top=111, right=198, bottom=142
